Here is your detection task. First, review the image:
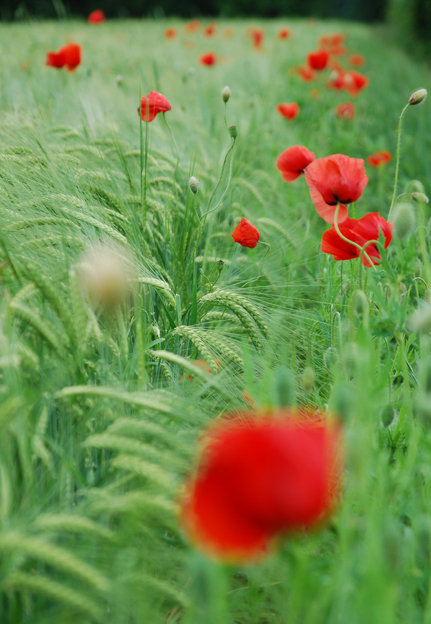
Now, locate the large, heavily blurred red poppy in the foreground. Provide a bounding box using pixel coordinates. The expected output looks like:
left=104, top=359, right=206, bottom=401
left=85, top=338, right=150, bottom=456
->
left=181, top=411, right=342, bottom=561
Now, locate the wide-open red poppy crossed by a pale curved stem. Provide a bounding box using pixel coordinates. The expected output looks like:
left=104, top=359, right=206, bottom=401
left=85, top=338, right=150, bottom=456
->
left=321, top=212, right=392, bottom=266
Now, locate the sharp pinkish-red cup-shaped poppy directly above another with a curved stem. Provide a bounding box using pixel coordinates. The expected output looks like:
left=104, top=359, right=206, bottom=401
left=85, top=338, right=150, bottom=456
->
left=304, top=154, right=368, bottom=223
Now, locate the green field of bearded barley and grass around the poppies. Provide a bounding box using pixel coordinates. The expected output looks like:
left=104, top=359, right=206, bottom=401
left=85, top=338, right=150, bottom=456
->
left=0, top=14, right=431, bottom=624
